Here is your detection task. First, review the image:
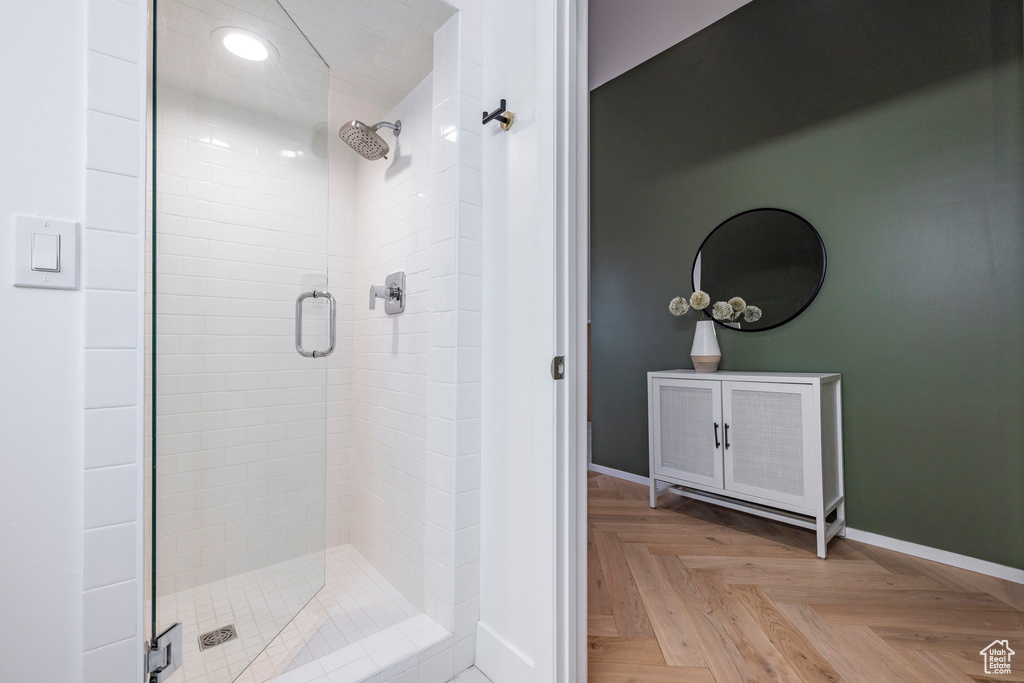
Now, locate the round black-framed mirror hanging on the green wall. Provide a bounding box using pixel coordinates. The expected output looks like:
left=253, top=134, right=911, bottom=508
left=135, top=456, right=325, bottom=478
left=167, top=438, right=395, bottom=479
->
left=692, top=209, right=825, bottom=332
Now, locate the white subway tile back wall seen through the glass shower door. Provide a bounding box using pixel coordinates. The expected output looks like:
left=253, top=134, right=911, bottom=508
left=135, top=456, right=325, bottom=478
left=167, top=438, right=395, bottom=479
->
left=148, top=72, right=328, bottom=595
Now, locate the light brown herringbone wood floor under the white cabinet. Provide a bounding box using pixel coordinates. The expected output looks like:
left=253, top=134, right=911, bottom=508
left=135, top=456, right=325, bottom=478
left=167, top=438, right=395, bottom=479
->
left=587, top=472, right=1024, bottom=683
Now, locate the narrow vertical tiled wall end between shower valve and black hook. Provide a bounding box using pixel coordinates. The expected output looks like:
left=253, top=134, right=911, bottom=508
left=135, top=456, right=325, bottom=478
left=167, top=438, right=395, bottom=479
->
left=425, top=20, right=484, bottom=680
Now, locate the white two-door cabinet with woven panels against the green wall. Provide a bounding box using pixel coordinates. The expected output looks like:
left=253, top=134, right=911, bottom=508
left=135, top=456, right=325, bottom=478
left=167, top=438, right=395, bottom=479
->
left=647, top=370, right=846, bottom=558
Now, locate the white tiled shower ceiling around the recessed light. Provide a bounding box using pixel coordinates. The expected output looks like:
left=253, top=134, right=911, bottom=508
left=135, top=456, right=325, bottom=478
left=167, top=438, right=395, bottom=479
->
left=161, top=0, right=455, bottom=120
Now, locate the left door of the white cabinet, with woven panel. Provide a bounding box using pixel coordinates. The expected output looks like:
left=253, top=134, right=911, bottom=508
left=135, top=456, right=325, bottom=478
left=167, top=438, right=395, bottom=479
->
left=651, top=379, right=724, bottom=488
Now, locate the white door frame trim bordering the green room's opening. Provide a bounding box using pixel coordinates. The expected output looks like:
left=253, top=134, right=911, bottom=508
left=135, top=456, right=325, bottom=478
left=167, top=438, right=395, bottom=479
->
left=554, top=0, right=590, bottom=683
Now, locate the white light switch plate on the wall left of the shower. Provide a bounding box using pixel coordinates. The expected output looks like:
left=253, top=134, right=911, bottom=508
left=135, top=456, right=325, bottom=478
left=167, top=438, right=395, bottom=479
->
left=14, top=216, right=78, bottom=290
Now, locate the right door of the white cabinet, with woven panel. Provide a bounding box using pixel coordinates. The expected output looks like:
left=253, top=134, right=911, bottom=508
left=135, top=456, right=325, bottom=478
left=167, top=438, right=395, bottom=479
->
left=722, top=382, right=818, bottom=510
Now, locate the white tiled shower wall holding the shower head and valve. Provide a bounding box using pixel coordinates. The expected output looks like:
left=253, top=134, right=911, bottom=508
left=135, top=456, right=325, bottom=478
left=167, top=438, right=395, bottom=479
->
left=328, top=17, right=482, bottom=655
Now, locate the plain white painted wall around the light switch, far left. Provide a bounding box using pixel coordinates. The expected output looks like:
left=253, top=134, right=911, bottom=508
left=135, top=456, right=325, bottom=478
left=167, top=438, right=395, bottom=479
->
left=0, top=0, right=86, bottom=681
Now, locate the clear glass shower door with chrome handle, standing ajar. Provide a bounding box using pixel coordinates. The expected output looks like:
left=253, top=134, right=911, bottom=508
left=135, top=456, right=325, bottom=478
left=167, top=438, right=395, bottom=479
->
left=146, top=0, right=332, bottom=683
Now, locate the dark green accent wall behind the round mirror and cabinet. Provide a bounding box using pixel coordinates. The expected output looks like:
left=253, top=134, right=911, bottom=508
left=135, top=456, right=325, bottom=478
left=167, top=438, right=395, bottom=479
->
left=591, top=0, right=1024, bottom=568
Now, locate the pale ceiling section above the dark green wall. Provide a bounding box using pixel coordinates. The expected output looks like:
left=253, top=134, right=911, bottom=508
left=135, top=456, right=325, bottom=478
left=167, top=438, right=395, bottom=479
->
left=589, top=0, right=751, bottom=90
